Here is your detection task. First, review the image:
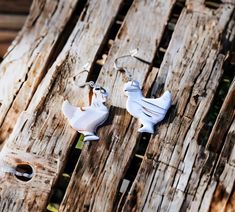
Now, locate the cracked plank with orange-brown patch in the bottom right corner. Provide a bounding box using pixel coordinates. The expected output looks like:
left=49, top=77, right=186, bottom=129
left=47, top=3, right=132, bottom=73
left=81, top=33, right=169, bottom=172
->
left=200, top=117, right=235, bottom=212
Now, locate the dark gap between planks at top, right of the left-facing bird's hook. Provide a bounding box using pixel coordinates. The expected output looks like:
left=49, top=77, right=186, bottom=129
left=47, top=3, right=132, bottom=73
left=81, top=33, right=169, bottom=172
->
left=153, top=0, right=185, bottom=68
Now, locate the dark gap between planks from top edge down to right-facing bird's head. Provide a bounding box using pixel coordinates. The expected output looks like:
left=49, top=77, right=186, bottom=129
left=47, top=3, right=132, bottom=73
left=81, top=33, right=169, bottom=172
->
left=87, top=0, right=134, bottom=82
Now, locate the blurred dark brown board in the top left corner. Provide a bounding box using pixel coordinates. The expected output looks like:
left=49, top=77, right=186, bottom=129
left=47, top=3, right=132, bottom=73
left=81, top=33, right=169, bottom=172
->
left=0, top=0, right=33, bottom=14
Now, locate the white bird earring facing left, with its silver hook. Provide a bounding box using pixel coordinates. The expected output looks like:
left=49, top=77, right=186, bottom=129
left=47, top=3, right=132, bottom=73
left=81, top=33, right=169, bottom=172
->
left=114, top=51, right=172, bottom=133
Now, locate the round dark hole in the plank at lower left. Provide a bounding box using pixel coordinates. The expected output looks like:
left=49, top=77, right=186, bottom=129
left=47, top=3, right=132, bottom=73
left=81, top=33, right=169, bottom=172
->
left=15, top=164, right=33, bottom=182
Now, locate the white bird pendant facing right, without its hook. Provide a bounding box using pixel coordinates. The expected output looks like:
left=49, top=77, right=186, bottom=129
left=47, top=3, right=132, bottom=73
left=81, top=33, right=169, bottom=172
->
left=62, top=86, right=109, bottom=141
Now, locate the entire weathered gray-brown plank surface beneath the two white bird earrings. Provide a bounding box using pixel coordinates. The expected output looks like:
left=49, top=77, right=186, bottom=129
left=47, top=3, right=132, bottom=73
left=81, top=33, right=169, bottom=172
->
left=0, top=0, right=235, bottom=212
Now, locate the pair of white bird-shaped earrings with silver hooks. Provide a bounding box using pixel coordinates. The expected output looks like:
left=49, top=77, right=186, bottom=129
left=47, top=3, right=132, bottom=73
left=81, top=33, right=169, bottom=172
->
left=62, top=51, right=172, bottom=141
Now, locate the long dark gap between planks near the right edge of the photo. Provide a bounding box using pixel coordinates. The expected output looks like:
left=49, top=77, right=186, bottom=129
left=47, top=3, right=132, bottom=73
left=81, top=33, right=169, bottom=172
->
left=198, top=58, right=235, bottom=146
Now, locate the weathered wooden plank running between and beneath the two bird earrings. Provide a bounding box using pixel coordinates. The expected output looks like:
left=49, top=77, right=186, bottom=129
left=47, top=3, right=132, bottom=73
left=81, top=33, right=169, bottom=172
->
left=60, top=0, right=174, bottom=211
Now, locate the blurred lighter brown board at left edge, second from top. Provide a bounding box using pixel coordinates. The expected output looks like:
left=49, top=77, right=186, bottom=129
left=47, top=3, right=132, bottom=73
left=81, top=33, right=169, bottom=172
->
left=0, top=14, right=27, bottom=30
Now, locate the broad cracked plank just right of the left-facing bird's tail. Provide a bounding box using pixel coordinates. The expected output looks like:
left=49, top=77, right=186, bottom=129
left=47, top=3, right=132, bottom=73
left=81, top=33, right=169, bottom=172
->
left=123, top=1, right=234, bottom=211
